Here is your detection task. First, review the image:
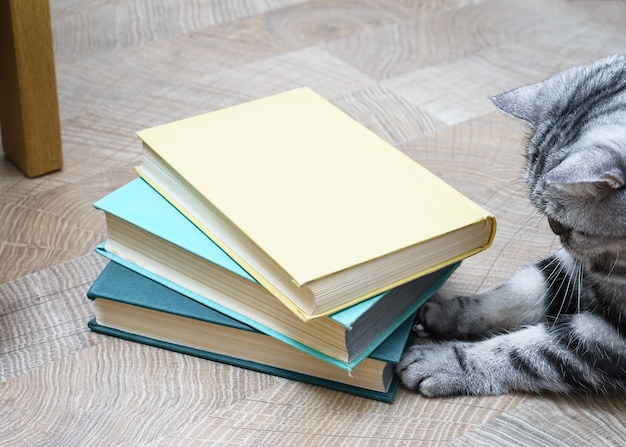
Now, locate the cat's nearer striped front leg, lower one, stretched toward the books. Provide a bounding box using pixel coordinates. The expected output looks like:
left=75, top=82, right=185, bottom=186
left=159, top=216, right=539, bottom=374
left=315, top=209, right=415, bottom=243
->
left=397, top=313, right=626, bottom=397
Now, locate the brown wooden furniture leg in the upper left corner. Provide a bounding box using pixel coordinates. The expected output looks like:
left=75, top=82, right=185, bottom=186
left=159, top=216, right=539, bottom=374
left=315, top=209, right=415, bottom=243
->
left=0, top=0, right=63, bottom=177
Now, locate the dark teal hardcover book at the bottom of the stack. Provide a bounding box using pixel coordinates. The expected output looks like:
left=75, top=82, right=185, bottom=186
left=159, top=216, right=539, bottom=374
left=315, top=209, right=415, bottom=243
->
left=87, top=262, right=413, bottom=402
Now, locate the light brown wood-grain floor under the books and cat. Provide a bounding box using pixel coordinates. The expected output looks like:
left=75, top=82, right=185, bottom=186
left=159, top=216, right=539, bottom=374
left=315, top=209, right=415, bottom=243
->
left=0, top=0, right=626, bottom=446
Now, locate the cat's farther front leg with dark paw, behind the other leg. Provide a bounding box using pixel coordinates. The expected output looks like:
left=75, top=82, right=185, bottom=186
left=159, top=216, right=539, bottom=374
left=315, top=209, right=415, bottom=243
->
left=414, top=255, right=566, bottom=339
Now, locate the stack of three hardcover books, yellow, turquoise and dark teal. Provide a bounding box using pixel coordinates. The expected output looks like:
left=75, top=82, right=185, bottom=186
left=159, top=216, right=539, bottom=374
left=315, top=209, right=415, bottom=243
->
left=88, top=88, right=495, bottom=402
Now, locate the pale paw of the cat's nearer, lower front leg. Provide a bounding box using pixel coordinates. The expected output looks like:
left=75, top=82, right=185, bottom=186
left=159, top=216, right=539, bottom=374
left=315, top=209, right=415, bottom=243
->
left=396, top=343, right=474, bottom=397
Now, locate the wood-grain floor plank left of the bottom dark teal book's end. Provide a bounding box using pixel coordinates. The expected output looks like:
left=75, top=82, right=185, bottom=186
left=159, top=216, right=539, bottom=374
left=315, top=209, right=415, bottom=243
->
left=0, top=253, right=106, bottom=382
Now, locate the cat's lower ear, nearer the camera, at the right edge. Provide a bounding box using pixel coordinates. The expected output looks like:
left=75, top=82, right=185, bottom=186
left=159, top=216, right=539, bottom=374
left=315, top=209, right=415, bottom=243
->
left=545, top=148, right=626, bottom=195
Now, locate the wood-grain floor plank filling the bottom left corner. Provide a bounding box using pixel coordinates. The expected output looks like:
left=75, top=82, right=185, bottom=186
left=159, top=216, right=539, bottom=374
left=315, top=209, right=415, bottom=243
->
left=0, top=334, right=282, bottom=446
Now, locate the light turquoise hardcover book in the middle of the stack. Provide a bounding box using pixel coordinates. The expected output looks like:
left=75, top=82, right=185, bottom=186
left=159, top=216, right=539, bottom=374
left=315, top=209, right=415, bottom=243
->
left=95, top=179, right=458, bottom=371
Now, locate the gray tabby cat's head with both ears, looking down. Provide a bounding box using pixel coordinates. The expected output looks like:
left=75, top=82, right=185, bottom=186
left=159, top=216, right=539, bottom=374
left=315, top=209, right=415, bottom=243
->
left=492, top=56, right=626, bottom=258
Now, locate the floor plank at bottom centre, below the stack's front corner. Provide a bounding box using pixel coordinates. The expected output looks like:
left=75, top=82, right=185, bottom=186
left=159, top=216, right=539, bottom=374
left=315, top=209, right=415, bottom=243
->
left=155, top=381, right=522, bottom=447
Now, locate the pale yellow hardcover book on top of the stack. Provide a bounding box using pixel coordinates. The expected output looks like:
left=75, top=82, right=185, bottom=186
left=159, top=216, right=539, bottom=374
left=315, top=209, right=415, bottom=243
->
left=137, top=88, right=495, bottom=321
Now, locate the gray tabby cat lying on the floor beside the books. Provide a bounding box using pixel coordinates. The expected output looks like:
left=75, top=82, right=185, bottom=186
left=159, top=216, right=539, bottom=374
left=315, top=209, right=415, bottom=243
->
left=397, top=56, right=626, bottom=396
